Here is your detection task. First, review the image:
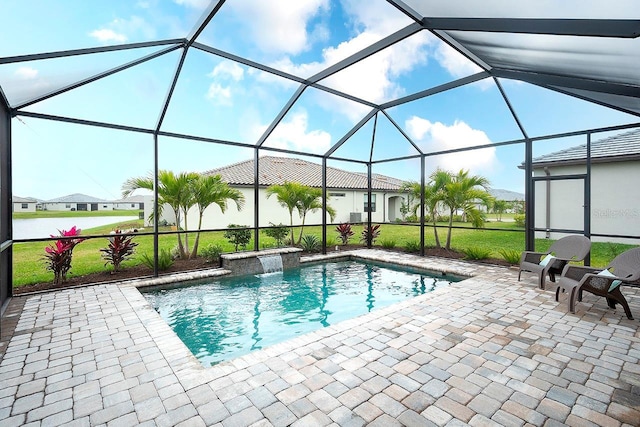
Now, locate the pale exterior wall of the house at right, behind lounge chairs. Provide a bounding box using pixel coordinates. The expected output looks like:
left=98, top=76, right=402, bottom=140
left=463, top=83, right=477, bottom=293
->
left=534, top=161, right=640, bottom=244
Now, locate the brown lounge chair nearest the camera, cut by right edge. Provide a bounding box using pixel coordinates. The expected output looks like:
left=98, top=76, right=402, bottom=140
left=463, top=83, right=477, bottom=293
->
left=556, top=248, right=640, bottom=319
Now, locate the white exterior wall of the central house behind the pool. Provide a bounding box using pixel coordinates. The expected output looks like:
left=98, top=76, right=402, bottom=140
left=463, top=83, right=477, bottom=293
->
left=144, top=188, right=402, bottom=230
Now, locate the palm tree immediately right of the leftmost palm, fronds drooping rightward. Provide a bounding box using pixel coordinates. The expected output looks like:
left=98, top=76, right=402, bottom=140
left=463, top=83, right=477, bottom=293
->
left=190, top=175, right=244, bottom=258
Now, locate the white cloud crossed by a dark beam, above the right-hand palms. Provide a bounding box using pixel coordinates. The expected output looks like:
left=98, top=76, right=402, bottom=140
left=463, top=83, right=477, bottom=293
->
left=406, top=116, right=498, bottom=173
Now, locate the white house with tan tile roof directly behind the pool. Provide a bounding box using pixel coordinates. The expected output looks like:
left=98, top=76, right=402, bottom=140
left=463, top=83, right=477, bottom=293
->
left=145, top=156, right=404, bottom=229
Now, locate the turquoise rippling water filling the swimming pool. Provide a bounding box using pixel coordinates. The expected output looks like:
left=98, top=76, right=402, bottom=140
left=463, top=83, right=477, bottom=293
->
left=143, top=261, right=459, bottom=366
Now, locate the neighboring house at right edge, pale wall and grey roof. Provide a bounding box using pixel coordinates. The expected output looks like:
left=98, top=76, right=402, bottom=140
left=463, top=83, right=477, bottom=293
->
left=520, top=129, right=640, bottom=244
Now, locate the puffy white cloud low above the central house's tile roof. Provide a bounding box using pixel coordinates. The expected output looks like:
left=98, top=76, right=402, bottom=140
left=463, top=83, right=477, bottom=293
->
left=255, top=110, right=331, bottom=153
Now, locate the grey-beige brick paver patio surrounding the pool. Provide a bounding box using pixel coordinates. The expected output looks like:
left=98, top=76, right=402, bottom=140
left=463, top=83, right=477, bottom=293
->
left=0, top=250, right=640, bottom=427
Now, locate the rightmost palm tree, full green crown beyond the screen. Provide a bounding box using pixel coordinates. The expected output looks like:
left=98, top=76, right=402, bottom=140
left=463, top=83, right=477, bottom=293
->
left=436, top=169, right=492, bottom=249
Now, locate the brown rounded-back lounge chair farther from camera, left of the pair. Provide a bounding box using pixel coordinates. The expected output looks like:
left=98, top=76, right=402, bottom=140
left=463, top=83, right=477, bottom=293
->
left=518, top=235, right=591, bottom=289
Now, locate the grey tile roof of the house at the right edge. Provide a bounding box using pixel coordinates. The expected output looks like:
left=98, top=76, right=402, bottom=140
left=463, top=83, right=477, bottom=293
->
left=533, top=129, right=640, bottom=165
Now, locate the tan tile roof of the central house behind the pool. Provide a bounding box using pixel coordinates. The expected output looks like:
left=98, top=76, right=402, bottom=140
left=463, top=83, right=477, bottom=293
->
left=205, top=156, right=404, bottom=191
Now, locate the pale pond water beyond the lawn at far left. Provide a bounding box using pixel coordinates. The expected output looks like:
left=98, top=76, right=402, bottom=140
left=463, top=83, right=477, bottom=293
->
left=13, top=216, right=138, bottom=239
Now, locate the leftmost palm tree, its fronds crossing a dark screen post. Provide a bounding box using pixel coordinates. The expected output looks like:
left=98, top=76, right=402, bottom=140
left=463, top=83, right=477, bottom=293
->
left=122, top=170, right=198, bottom=258
